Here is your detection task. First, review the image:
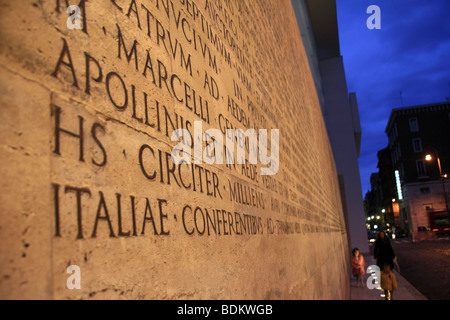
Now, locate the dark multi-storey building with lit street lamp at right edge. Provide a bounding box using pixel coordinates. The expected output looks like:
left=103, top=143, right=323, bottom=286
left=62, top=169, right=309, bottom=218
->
left=386, top=102, right=450, bottom=239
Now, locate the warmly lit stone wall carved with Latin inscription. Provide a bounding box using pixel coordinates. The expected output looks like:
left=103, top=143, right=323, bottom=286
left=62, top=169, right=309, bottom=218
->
left=0, top=0, right=349, bottom=299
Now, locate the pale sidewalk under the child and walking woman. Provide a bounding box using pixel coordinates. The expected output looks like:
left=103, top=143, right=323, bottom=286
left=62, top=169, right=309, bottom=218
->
left=350, top=256, right=428, bottom=300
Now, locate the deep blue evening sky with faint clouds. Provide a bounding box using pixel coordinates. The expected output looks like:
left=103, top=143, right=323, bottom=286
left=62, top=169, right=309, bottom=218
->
left=336, top=0, right=450, bottom=196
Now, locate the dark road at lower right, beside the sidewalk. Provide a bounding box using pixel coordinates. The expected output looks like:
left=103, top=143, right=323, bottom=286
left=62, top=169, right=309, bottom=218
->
left=392, top=239, right=450, bottom=300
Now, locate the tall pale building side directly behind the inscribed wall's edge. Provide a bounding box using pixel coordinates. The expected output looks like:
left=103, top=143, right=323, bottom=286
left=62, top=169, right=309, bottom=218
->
left=292, top=0, right=369, bottom=252
